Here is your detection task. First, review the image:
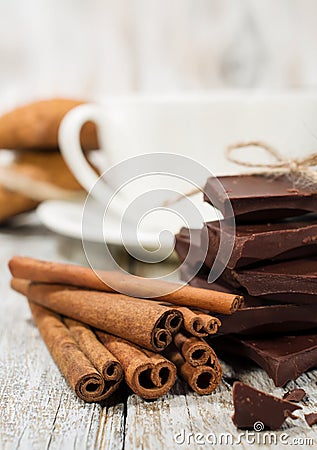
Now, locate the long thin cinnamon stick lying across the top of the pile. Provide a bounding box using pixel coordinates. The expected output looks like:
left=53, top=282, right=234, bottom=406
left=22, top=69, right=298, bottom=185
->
left=9, top=256, right=243, bottom=314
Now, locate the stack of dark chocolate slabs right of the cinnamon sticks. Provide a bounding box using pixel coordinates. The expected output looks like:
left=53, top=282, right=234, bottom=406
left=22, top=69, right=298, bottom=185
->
left=176, top=175, right=317, bottom=386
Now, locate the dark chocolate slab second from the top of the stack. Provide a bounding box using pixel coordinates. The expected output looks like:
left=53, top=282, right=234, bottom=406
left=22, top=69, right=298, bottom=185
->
left=202, top=214, right=317, bottom=269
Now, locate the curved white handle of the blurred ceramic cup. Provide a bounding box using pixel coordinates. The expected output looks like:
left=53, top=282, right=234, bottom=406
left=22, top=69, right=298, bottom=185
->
left=58, top=104, right=102, bottom=192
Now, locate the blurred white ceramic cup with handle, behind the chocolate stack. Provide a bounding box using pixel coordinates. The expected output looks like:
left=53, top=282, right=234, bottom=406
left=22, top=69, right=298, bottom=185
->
left=59, top=91, right=317, bottom=207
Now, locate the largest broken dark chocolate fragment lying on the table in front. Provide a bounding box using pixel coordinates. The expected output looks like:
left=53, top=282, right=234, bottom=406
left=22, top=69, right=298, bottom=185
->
left=232, top=381, right=301, bottom=431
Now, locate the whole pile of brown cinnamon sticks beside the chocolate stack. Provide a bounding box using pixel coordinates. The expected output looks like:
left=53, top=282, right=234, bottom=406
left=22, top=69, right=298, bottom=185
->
left=9, top=256, right=243, bottom=402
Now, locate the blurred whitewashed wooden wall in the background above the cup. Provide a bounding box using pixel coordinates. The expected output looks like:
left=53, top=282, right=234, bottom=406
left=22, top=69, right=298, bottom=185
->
left=0, top=0, right=317, bottom=108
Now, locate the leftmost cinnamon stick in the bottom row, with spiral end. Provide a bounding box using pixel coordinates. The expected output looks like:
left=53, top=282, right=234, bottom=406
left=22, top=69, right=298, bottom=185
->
left=29, top=301, right=118, bottom=402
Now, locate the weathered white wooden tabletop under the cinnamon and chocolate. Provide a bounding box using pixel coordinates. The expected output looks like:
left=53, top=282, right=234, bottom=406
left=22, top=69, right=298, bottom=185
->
left=0, top=216, right=317, bottom=450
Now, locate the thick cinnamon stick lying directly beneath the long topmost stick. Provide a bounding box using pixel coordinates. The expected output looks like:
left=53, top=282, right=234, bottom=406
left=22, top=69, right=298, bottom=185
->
left=11, top=278, right=182, bottom=351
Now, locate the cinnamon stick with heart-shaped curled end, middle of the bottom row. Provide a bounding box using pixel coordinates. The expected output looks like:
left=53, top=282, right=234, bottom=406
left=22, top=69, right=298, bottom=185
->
left=97, top=331, right=176, bottom=399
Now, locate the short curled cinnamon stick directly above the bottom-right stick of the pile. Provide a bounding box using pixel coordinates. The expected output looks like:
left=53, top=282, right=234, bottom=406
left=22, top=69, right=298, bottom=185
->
left=174, top=333, right=221, bottom=372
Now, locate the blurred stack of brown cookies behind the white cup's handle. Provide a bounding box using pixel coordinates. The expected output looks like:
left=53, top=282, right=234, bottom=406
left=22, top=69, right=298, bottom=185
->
left=0, top=99, right=98, bottom=223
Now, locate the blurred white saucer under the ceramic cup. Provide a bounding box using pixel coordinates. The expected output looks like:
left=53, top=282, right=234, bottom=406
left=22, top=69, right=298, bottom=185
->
left=37, top=199, right=217, bottom=259
